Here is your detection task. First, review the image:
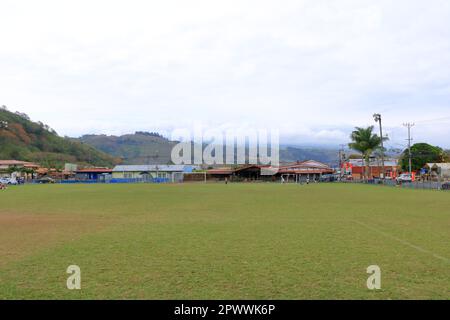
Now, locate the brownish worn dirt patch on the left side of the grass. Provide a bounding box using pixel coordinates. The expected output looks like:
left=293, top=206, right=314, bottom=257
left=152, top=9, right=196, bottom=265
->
left=0, top=213, right=111, bottom=267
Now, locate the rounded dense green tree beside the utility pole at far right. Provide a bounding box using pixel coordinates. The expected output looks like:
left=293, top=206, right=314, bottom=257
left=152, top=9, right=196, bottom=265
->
left=400, top=143, right=447, bottom=171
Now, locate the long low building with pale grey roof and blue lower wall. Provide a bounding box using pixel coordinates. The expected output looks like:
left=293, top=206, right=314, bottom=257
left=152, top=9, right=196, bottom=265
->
left=112, top=165, right=192, bottom=182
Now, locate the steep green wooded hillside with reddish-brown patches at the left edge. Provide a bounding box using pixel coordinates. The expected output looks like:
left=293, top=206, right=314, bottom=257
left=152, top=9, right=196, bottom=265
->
left=0, top=106, right=120, bottom=168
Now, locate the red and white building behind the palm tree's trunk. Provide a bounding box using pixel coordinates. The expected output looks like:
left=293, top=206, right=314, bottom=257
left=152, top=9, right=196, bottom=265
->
left=342, top=158, right=401, bottom=180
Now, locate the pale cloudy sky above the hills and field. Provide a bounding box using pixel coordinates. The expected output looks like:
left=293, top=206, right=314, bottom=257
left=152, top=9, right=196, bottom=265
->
left=0, top=0, right=450, bottom=147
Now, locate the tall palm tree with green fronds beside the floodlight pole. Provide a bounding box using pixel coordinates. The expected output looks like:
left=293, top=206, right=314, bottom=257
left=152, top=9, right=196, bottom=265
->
left=348, top=126, right=388, bottom=180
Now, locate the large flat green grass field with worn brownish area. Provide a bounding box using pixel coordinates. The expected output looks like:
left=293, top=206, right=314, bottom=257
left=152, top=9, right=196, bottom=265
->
left=0, top=184, right=450, bottom=299
